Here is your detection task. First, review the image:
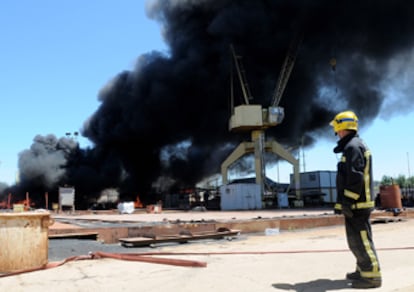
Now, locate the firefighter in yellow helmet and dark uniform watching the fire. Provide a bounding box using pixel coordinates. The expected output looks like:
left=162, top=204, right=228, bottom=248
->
left=330, top=111, right=382, bottom=289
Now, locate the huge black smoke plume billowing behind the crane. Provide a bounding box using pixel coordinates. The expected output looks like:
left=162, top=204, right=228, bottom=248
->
left=2, top=0, right=414, bottom=205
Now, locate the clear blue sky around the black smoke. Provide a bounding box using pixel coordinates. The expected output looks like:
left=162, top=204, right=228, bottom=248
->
left=0, top=0, right=414, bottom=184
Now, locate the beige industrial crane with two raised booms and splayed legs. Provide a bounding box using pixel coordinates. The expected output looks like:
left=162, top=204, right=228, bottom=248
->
left=221, top=36, right=302, bottom=205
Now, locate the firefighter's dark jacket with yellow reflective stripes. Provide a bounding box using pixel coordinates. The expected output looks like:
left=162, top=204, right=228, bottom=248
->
left=334, top=131, right=375, bottom=212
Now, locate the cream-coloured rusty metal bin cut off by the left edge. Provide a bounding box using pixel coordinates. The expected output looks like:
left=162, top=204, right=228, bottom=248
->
left=0, top=211, right=52, bottom=273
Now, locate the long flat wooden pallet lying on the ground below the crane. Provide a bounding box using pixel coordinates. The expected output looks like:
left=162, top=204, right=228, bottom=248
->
left=119, top=228, right=240, bottom=247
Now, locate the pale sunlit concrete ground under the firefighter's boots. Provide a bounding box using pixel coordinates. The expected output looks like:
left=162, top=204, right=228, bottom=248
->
left=0, top=209, right=414, bottom=292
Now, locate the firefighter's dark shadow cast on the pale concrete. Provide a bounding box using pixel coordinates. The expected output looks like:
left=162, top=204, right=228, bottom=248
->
left=272, top=279, right=351, bottom=292
